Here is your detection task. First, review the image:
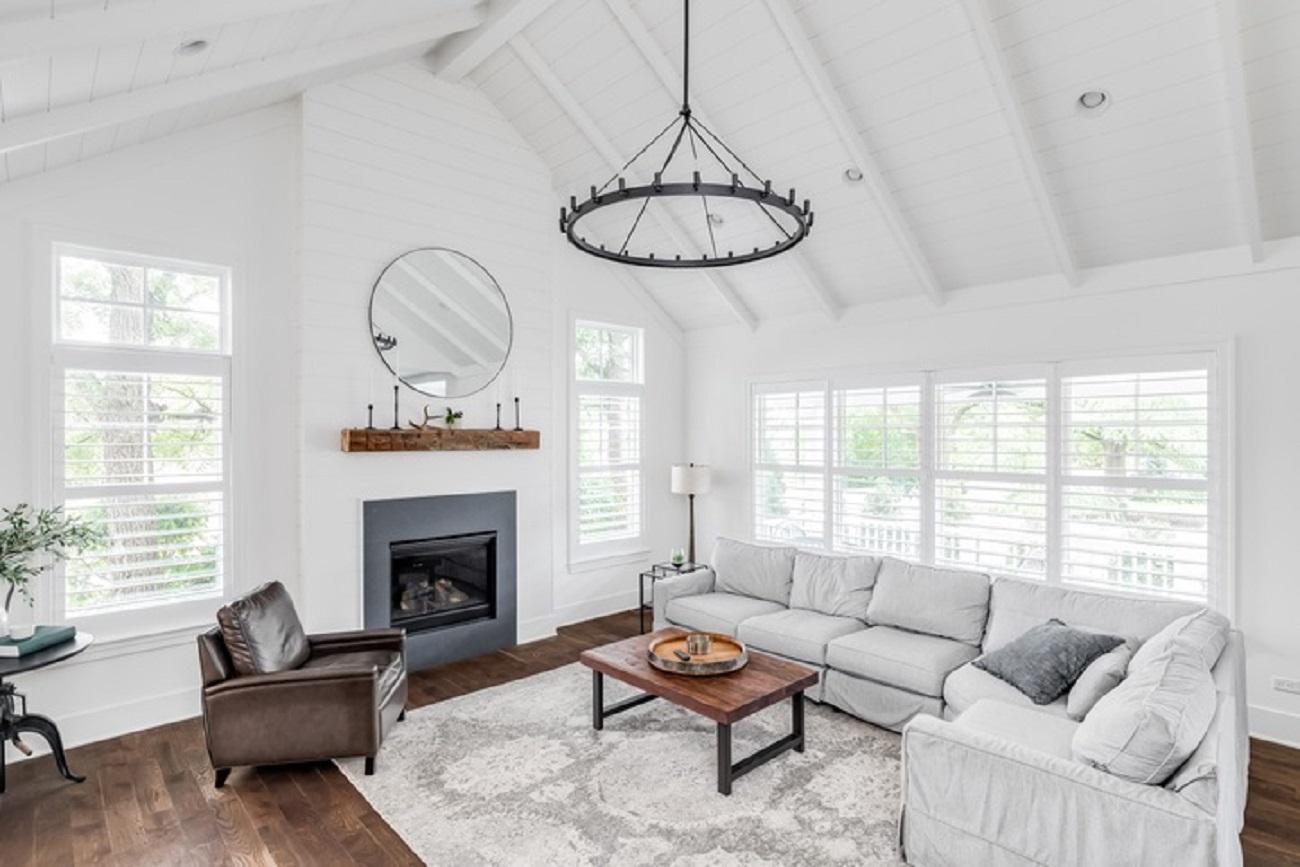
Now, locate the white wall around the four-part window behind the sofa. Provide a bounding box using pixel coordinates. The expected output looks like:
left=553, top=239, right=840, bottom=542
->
left=686, top=248, right=1300, bottom=744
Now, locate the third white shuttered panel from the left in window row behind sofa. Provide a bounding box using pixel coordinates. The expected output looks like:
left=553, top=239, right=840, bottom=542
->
left=935, top=378, right=1048, bottom=577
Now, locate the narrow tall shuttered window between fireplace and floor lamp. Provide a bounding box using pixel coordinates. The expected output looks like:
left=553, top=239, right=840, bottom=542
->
left=571, top=321, right=645, bottom=560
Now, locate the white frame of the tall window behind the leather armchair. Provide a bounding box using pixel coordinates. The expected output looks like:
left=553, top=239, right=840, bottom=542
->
left=36, top=240, right=235, bottom=638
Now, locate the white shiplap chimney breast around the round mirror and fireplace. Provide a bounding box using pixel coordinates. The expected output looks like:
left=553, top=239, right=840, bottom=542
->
left=300, top=59, right=556, bottom=632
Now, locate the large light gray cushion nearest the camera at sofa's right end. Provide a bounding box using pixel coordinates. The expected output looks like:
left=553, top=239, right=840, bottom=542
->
left=1071, top=646, right=1218, bottom=785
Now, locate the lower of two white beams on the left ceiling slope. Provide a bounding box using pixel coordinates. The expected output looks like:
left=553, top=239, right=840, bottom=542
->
left=0, top=9, right=480, bottom=153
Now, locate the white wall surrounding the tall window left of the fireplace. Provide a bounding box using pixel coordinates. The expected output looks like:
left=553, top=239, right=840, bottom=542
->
left=0, top=105, right=298, bottom=757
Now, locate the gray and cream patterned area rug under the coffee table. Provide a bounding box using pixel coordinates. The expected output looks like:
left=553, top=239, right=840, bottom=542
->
left=339, top=664, right=900, bottom=867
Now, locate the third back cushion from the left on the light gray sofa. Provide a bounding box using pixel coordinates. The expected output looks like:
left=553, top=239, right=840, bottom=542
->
left=867, top=556, right=987, bottom=647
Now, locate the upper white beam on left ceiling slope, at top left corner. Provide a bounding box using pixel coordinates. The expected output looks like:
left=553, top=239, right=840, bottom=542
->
left=0, top=0, right=351, bottom=64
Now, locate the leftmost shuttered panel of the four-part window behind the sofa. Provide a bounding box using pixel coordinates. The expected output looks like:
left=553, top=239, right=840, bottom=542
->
left=753, top=383, right=827, bottom=546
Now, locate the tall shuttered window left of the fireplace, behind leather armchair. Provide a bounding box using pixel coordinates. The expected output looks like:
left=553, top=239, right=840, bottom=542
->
left=52, top=246, right=230, bottom=616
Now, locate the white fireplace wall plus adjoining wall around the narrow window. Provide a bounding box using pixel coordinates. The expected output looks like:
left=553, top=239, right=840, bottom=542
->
left=300, top=64, right=683, bottom=640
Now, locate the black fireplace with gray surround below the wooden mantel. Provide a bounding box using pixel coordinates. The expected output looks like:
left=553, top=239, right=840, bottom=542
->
left=361, top=491, right=517, bottom=671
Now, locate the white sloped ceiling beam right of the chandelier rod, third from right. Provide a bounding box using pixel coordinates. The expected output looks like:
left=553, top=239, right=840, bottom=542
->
left=766, top=0, right=944, bottom=304
